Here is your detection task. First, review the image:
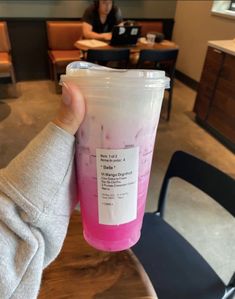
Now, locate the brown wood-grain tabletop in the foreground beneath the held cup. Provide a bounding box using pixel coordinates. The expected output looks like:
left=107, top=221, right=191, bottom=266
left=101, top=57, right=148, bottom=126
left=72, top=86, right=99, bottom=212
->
left=38, top=211, right=157, bottom=299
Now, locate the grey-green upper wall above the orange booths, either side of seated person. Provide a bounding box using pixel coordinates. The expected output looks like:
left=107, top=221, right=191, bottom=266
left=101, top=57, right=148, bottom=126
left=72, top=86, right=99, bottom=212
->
left=0, top=0, right=176, bottom=18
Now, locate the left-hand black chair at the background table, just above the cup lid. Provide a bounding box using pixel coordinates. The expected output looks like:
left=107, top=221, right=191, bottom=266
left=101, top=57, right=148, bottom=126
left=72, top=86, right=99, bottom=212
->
left=86, top=49, right=130, bottom=68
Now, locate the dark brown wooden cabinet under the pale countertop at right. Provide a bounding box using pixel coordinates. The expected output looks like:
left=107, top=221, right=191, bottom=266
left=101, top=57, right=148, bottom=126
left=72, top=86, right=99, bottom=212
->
left=194, top=47, right=235, bottom=150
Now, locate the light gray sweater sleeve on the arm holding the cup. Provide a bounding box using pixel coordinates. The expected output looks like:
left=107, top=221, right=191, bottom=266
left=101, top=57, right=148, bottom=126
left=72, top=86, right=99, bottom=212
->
left=0, top=123, right=76, bottom=299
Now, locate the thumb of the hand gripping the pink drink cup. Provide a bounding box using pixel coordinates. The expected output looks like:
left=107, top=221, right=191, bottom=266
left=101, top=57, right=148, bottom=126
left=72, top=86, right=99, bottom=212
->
left=53, top=82, right=85, bottom=135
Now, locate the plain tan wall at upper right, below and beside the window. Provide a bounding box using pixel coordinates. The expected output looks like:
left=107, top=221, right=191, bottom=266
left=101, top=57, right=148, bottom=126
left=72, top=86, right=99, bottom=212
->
left=173, top=0, right=235, bottom=81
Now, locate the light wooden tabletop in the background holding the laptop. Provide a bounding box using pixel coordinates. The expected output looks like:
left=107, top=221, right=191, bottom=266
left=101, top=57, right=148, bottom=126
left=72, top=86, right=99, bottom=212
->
left=74, top=40, right=178, bottom=53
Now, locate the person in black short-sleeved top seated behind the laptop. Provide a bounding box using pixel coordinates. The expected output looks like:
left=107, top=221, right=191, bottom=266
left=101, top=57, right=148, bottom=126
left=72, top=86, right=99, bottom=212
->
left=82, top=0, right=123, bottom=40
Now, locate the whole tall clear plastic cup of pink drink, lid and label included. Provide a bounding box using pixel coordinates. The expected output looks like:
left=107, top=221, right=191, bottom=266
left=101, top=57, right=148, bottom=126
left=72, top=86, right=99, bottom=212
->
left=61, top=62, right=169, bottom=251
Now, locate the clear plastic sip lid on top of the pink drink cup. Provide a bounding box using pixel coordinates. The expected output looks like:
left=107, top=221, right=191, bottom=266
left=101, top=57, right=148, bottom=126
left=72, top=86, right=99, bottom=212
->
left=61, top=61, right=170, bottom=88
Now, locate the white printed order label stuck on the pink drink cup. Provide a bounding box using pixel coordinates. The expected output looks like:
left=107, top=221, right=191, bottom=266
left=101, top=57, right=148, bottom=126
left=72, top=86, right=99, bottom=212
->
left=96, top=147, right=139, bottom=225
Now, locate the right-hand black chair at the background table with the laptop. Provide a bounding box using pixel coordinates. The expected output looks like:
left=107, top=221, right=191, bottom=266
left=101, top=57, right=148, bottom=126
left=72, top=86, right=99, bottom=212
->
left=137, top=49, right=179, bottom=121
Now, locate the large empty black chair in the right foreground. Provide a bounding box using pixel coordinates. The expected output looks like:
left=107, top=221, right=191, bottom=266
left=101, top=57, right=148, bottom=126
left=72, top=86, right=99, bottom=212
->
left=132, top=151, right=235, bottom=299
